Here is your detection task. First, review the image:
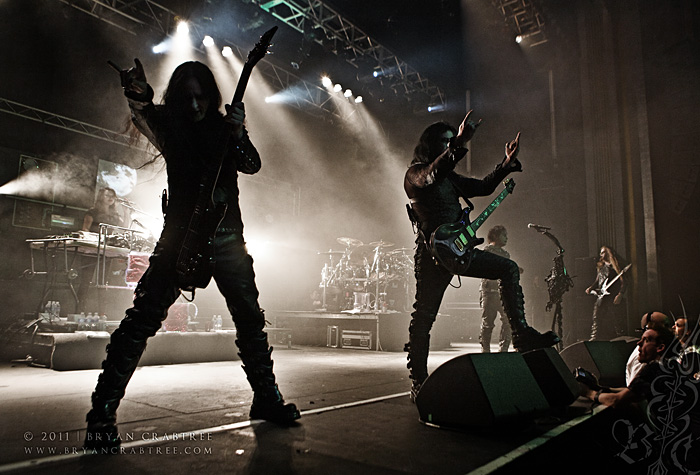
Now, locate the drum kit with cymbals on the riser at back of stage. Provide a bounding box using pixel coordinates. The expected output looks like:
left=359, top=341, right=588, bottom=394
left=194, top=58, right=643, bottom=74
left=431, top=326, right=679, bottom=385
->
left=318, top=237, right=413, bottom=312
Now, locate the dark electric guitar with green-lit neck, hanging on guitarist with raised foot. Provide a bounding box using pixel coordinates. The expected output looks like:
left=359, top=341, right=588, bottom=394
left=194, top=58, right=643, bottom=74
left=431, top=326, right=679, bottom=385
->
left=430, top=178, right=515, bottom=268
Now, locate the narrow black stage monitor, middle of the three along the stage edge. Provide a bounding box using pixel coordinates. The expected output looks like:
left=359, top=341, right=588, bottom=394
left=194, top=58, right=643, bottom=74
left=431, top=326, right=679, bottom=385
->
left=523, top=348, right=579, bottom=407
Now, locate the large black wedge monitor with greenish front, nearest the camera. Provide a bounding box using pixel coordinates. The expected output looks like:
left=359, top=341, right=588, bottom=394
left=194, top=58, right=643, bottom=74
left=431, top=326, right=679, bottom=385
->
left=416, top=353, right=549, bottom=428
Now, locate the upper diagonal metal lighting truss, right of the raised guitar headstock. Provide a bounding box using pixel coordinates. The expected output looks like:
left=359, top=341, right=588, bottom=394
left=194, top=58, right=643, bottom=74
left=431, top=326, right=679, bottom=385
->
left=251, top=0, right=445, bottom=105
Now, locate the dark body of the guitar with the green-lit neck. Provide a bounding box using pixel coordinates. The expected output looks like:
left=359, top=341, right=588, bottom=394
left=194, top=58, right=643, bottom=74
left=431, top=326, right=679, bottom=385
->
left=430, top=207, right=484, bottom=267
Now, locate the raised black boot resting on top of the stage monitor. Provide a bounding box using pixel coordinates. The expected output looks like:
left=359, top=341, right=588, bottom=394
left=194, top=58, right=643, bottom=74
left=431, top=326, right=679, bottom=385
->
left=501, top=263, right=559, bottom=353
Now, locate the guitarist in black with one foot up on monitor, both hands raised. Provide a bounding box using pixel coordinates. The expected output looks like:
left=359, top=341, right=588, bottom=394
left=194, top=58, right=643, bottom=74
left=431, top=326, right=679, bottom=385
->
left=404, top=111, right=559, bottom=399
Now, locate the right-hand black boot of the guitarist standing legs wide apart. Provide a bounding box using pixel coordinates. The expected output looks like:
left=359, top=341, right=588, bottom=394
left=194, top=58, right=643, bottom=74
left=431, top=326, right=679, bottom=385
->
left=236, top=331, right=301, bottom=425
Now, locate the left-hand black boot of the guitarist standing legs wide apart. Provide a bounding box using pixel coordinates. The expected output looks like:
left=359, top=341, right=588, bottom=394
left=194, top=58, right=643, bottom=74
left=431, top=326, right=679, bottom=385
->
left=84, top=328, right=146, bottom=450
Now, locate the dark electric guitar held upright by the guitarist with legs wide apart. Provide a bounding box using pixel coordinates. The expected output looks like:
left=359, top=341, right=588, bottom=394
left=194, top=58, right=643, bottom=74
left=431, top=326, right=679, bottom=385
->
left=175, top=26, right=277, bottom=291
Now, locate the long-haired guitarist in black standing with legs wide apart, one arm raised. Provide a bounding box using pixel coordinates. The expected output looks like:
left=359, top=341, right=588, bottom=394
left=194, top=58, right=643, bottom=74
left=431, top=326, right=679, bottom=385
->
left=85, top=59, right=300, bottom=448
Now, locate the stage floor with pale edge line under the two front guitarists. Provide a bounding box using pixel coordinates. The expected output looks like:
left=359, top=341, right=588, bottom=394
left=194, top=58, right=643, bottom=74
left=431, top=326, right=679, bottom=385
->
left=0, top=345, right=644, bottom=475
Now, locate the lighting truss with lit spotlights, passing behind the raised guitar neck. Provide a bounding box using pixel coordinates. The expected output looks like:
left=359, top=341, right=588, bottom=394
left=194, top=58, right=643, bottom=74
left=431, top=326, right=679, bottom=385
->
left=59, top=0, right=350, bottom=118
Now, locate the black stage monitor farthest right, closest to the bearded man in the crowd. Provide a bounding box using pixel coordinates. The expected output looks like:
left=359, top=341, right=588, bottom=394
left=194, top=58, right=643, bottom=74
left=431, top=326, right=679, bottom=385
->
left=561, top=340, right=636, bottom=387
